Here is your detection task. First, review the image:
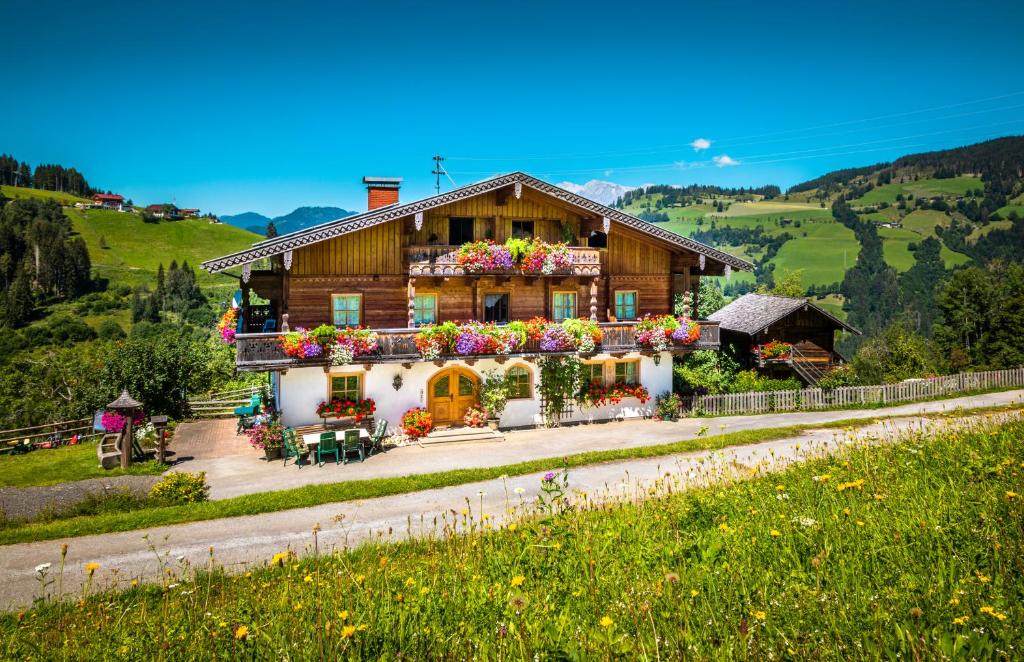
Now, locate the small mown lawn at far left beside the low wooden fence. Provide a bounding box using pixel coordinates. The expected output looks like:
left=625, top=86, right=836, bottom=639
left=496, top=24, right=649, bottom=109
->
left=0, top=442, right=167, bottom=488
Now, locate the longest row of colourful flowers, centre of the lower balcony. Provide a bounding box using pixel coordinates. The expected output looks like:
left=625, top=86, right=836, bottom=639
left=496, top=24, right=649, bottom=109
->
left=416, top=318, right=602, bottom=361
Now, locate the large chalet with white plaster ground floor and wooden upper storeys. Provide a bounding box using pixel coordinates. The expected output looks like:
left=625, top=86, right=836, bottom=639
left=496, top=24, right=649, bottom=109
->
left=203, top=172, right=752, bottom=427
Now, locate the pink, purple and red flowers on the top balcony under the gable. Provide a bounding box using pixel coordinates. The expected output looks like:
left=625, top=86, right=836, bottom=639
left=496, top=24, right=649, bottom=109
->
left=457, top=239, right=572, bottom=274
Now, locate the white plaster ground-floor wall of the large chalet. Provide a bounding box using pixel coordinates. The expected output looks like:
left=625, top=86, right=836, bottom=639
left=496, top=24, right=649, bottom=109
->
left=273, top=351, right=672, bottom=429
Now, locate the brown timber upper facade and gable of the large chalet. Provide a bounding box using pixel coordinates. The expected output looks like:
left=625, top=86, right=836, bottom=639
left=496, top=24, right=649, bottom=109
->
left=204, top=173, right=751, bottom=332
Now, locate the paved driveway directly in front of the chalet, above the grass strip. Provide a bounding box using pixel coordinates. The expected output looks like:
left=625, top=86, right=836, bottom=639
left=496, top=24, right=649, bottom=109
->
left=172, top=390, right=1024, bottom=499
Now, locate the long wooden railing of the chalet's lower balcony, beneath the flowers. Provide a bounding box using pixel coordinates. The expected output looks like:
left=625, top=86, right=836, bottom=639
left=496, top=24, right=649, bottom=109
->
left=236, top=321, right=719, bottom=371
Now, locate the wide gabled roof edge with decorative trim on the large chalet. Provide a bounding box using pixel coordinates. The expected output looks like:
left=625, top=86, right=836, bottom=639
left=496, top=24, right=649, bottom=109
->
left=202, top=172, right=754, bottom=273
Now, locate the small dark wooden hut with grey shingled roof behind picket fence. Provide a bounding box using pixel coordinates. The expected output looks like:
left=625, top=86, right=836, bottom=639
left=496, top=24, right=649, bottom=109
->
left=710, top=293, right=860, bottom=386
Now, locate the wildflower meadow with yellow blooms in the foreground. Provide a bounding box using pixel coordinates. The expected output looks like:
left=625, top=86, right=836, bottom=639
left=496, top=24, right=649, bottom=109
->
left=0, top=420, right=1024, bottom=660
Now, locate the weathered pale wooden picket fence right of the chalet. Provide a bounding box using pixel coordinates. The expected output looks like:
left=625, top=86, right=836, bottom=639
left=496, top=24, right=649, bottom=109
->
left=691, top=368, right=1024, bottom=416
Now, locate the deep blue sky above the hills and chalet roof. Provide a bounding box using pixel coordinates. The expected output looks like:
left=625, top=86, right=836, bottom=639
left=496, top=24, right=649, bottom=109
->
left=0, top=0, right=1024, bottom=215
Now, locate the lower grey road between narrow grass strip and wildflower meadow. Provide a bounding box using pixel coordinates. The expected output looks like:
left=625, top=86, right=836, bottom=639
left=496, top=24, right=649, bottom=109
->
left=0, top=394, right=1021, bottom=609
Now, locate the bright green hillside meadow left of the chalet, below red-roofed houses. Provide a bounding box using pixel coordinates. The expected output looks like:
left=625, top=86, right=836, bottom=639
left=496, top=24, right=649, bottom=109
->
left=65, top=208, right=262, bottom=291
